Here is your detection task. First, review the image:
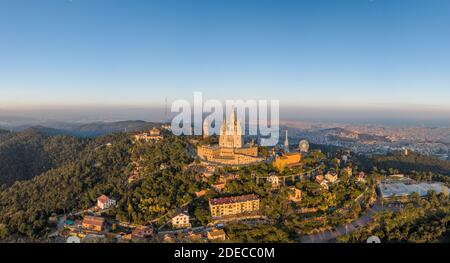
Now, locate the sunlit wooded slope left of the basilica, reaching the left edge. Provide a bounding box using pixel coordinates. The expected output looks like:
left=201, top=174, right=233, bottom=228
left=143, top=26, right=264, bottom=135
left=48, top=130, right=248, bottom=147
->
left=0, top=133, right=201, bottom=240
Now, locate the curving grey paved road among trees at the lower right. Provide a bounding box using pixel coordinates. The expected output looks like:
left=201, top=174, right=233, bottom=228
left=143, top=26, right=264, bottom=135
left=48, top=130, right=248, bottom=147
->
left=300, top=200, right=386, bottom=243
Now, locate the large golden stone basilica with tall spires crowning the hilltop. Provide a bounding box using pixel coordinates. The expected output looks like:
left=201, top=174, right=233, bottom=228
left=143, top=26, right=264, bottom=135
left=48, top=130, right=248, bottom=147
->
left=197, top=110, right=264, bottom=165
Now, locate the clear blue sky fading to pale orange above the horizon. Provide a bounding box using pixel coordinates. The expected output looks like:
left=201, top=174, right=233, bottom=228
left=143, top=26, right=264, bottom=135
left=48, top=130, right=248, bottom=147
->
left=0, top=0, right=450, bottom=114
